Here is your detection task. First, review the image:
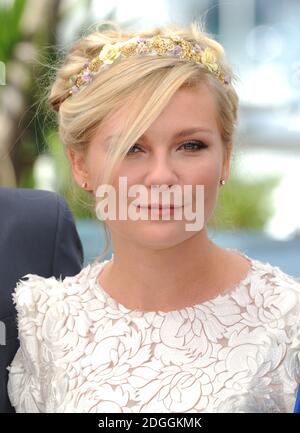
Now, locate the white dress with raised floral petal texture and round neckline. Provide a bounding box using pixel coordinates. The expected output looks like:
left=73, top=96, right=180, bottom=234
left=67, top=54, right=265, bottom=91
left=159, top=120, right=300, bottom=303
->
left=8, top=253, right=300, bottom=413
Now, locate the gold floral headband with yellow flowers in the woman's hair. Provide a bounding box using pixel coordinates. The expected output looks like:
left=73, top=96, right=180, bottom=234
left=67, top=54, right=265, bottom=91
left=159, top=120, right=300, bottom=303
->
left=69, top=35, right=230, bottom=96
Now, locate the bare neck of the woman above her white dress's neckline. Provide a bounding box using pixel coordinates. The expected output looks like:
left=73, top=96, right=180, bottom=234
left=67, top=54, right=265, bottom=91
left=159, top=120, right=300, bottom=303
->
left=99, top=232, right=245, bottom=311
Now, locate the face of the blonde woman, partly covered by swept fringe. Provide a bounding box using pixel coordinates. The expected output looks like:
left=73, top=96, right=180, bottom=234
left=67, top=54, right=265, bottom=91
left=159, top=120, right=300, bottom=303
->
left=69, top=84, right=230, bottom=249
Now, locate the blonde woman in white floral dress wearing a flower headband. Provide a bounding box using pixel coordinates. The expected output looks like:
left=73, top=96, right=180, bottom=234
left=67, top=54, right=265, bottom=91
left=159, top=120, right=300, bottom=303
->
left=8, top=20, right=300, bottom=413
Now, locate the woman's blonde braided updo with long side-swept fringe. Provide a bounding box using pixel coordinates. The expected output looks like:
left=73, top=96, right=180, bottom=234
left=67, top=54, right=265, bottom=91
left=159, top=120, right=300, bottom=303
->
left=48, top=22, right=238, bottom=264
